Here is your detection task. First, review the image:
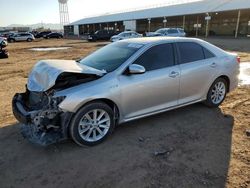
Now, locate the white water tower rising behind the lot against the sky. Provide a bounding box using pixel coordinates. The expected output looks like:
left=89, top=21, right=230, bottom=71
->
left=58, top=0, right=69, bottom=29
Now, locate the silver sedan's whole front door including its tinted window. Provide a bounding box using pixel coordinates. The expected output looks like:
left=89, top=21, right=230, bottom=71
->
left=119, top=43, right=180, bottom=119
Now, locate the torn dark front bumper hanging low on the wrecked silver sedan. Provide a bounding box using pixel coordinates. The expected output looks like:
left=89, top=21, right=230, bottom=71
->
left=12, top=93, right=73, bottom=146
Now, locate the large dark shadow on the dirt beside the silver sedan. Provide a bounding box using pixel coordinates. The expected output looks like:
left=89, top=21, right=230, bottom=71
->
left=0, top=104, right=234, bottom=188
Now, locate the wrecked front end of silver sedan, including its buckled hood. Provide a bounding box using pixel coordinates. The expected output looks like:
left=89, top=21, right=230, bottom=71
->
left=12, top=60, right=103, bottom=146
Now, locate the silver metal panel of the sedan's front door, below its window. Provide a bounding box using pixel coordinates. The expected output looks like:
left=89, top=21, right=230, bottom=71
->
left=119, top=65, right=180, bottom=119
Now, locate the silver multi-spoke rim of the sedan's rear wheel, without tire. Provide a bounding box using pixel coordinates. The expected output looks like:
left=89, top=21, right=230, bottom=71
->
left=211, top=82, right=226, bottom=104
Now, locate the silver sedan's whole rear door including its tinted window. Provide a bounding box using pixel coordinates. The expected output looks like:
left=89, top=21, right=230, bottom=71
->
left=177, top=42, right=217, bottom=104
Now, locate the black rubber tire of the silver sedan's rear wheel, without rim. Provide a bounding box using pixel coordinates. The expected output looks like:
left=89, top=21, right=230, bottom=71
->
left=204, top=78, right=228, bottom=108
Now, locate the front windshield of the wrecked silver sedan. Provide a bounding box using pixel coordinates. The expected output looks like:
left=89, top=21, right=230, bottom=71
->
left=79, top=42, right=143, bottom=72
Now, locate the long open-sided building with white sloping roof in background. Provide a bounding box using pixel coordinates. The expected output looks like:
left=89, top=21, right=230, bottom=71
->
left=64, top=0, right=250, bottom=37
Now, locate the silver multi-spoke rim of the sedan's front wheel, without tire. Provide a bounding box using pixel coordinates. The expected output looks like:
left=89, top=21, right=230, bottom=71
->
left=78, top=109, right=111, bottom=142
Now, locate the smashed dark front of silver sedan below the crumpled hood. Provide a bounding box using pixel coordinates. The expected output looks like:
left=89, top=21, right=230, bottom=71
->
left=12, top=89, right=73, bottom=146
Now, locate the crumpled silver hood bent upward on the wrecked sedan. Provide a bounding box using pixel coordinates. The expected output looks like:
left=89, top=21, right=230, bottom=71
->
left=27, top=60, right=106, bottom=92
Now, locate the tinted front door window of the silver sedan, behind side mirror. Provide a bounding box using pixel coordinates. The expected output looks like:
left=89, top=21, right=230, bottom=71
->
left=134, top=44, right=174, bottom=71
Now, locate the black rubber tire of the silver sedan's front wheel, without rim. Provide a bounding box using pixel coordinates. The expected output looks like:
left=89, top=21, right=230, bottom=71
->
left=69, top=102, right=115, bottom=146
